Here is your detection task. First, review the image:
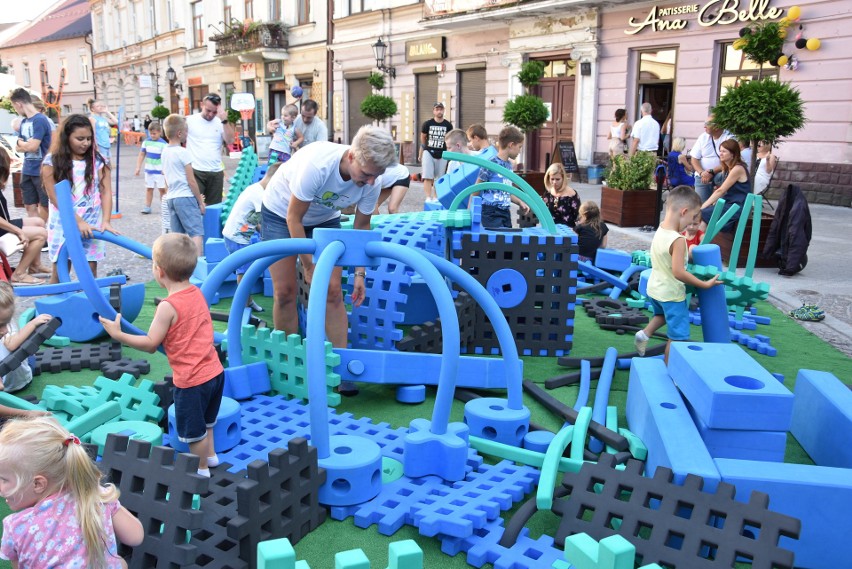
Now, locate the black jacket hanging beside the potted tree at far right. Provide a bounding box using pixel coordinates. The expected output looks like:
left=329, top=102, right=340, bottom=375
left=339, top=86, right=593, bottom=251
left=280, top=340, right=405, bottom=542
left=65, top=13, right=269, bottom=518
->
left=763, top=184, right=813, bottom=276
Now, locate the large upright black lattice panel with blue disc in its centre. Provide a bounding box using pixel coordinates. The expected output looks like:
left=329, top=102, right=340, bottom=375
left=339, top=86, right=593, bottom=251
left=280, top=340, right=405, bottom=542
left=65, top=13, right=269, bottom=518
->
left=452, top=225, right=577, bottom=356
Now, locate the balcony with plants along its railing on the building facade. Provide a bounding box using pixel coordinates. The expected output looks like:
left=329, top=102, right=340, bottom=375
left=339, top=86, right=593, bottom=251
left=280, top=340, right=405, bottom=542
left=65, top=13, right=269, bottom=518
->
left=210, top=22, right=289, bottom=67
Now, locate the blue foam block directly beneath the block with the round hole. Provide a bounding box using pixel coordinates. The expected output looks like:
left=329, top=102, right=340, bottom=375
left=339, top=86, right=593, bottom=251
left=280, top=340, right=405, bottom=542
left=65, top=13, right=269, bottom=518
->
left=686, top=394, right=787, bottom=462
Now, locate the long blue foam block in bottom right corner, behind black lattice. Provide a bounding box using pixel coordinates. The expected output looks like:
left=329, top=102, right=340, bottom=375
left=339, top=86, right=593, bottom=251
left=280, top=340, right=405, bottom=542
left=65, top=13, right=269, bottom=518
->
left=716, top=458, right=852, bottom=569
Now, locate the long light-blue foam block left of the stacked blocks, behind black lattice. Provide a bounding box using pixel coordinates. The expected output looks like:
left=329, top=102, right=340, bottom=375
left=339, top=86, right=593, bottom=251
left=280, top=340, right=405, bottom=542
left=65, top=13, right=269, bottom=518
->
left=626, top=358, right=719, bottom=492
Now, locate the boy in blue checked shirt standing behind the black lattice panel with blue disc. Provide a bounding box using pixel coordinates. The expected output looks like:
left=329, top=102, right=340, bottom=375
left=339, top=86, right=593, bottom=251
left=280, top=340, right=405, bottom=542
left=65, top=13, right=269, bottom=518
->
left=470, top=126, right=530, bottom=229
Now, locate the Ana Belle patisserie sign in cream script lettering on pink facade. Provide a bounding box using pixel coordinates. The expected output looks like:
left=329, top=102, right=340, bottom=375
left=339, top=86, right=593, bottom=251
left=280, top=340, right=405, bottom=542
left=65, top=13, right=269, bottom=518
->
left=624, top=0, right=784, bottom=35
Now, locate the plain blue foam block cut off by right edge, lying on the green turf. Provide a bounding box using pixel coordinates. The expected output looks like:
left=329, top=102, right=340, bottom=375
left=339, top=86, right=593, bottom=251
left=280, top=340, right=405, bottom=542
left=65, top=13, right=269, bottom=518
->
left=790, top=369, right=852, bottom=466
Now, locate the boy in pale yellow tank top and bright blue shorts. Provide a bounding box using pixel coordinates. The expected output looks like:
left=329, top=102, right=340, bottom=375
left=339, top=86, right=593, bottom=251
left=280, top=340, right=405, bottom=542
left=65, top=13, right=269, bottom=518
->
left=633, top=186, right=719, bottom=363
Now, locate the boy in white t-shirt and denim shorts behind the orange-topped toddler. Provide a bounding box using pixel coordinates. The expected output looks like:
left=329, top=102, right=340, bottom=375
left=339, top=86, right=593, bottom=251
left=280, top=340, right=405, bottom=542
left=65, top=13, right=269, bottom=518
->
left=162, top=114, right=204, bottom=257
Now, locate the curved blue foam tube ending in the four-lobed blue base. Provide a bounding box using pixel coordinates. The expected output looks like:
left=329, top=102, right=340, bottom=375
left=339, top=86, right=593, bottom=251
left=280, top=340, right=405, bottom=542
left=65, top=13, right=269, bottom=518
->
left=365, top=241, right=461, bottom=435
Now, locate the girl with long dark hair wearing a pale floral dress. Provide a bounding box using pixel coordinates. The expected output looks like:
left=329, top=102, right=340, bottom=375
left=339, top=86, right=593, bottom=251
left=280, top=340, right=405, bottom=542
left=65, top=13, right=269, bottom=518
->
left=41, top=114, right=118, bottom=283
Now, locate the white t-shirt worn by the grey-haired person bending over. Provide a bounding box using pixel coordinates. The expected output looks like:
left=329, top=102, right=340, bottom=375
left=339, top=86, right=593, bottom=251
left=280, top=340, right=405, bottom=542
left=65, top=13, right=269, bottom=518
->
left=263, top=141, right=381, bottom=227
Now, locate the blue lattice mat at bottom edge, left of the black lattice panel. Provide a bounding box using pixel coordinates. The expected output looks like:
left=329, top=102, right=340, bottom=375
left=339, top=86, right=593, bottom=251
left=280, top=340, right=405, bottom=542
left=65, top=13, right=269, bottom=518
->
left=440, top=518, right=562, bottom=569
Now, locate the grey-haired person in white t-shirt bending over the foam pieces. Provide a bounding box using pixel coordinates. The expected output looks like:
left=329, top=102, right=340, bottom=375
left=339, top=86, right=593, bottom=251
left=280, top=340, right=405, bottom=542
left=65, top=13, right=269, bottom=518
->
left=261, top=126, right=396, bottom=390
